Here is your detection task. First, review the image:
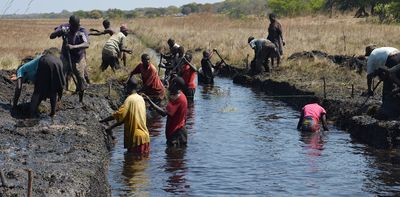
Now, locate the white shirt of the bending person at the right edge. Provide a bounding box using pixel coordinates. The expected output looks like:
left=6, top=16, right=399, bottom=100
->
left=367, top=47, right=399, bottom=74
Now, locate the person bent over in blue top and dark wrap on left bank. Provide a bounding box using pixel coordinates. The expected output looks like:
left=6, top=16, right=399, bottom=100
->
left=11, top=48, right=65, bottom=116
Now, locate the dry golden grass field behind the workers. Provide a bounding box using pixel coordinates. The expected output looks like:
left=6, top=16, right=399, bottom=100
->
left=0, top=14, right=400, bottom=97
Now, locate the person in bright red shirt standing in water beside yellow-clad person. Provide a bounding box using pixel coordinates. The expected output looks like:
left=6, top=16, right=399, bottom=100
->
left=144, top=77, right=187, bottom=147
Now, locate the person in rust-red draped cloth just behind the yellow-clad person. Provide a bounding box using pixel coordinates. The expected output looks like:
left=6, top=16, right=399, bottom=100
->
left=129, top=53, right=165, bottom=103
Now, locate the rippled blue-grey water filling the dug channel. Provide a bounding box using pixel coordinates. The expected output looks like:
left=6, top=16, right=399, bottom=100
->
left=109, top=79, right=400, bottom=196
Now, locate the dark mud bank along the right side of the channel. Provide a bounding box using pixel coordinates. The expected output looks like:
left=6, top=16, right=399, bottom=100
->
left=221, top=67, right=400, bottom=149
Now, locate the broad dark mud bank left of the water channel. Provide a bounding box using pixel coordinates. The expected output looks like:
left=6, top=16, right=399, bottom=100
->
left=0, top=71, right=121, bottom=196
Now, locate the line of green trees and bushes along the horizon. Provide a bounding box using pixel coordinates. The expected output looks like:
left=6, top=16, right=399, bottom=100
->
left=3, top=0, right=400, bottom=22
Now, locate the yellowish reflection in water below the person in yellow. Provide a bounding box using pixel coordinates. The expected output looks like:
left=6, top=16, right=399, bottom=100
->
left=122, top=153, right=150, bottom=196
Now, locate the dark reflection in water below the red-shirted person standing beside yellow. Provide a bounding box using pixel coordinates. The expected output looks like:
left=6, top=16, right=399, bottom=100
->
left=164, top=147, right=190, bottom=195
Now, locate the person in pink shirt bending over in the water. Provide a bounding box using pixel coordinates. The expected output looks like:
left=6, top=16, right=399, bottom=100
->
left=297, top=98, right=329, bottom=132
